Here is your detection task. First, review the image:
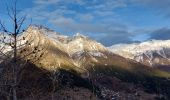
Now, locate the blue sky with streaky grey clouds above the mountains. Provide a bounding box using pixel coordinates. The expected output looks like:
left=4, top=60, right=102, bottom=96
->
left=0, top=0, right=170, bottom=46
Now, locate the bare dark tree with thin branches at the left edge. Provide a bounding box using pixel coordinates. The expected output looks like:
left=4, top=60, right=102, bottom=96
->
left=0, top=0, right=38, bottom=100
